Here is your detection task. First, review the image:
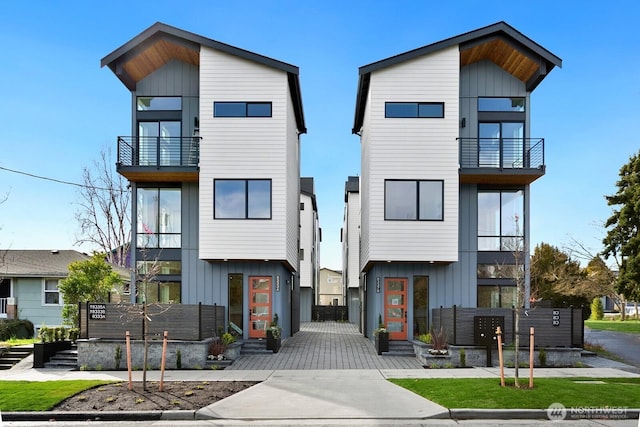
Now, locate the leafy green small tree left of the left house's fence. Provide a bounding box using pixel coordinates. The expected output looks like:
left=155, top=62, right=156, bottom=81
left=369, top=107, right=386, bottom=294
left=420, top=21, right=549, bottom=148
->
left=58, top=254, right=123, bottom=328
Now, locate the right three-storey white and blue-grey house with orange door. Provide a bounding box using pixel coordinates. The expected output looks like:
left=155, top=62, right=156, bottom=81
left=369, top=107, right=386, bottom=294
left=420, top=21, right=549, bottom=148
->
left=353, top=22, right=562, bottom=340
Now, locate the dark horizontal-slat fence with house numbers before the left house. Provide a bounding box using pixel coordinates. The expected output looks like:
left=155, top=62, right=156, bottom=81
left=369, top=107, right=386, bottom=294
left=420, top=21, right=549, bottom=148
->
left=78, top=303, right=225, bottom=341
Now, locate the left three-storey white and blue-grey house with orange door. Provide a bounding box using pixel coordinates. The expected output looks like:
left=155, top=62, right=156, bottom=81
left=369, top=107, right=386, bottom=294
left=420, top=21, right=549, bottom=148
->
left=101, top=23, right=306, bottom=338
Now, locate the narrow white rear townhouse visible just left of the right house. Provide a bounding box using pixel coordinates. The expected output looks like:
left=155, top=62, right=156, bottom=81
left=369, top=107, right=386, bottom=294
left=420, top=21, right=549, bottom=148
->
left=340, top=176, right=362, bottom=324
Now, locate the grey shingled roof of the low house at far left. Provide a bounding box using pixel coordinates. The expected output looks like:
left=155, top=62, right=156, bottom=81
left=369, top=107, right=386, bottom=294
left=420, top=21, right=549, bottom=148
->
left=0, top=250, right=91, bottom=277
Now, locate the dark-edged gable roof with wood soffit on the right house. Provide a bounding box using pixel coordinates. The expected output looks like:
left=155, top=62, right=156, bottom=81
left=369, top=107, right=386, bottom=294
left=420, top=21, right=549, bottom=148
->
left=352, top=21, right=562, bottom=133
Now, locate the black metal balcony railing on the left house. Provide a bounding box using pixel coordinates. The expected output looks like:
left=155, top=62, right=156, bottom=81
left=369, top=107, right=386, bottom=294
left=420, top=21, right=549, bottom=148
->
left=118, top=136, right=202, bottom=167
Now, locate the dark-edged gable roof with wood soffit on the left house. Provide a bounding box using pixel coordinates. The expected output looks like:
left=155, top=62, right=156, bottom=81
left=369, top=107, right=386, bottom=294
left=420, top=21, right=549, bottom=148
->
left=100, top=22, right=307, bottom=133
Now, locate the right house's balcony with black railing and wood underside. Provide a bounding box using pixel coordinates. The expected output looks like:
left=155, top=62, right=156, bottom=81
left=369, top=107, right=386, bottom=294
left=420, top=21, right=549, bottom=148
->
left=458, top=138, right=545, bottom=185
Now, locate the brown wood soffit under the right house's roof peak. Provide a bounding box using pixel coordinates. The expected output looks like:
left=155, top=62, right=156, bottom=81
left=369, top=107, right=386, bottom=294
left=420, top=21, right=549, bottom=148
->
left=460, top=39, right=540, bottom=83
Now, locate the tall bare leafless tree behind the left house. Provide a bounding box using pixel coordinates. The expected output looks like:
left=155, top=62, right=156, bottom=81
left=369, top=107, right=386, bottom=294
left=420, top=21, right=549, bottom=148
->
left=75, top=148, right=131, bottom=267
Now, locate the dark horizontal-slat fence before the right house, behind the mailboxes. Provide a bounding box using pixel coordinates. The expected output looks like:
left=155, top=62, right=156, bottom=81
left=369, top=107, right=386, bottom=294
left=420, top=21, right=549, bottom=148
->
left=431, top=306, right=584, bottom=347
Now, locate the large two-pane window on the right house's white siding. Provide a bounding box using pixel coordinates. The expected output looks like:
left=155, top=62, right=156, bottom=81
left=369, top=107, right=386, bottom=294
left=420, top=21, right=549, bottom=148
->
left=384, top=180, right=444, bottom=221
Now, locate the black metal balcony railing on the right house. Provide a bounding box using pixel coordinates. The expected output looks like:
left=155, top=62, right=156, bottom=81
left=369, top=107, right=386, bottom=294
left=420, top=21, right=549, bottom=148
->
left=458, top=138, right=544, bottom=169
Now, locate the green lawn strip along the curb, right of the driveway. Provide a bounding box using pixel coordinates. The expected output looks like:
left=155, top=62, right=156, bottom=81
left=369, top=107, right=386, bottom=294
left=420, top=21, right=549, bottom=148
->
left=390, top=377, right=640, bottom=409
